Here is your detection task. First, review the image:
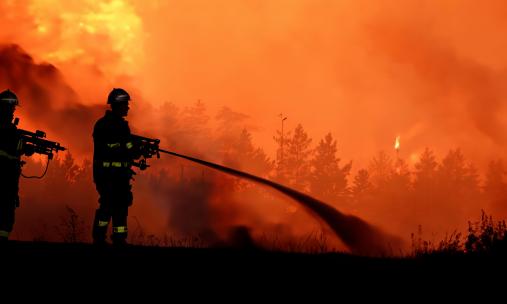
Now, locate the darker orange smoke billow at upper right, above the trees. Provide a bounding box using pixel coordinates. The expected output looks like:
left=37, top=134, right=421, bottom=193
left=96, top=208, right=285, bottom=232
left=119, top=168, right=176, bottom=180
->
left=366, top=6, right=507, bottom=164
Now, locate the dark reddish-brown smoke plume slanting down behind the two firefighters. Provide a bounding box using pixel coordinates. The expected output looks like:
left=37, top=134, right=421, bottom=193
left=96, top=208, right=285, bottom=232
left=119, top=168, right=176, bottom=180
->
left=0, top=45, right=102, bottom=154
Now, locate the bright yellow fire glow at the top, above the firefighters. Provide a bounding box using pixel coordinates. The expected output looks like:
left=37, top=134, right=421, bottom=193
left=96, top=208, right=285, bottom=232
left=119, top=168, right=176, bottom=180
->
left=29, top=0, right=144, bottom=75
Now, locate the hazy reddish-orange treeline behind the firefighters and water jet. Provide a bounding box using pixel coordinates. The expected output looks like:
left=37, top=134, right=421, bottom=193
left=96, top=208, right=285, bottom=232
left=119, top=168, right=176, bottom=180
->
left=13, top=102, right=507, bottom=243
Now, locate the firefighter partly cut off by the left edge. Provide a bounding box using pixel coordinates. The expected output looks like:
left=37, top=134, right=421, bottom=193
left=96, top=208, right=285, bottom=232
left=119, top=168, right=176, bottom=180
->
left=0, top=90, right=33, bottom=242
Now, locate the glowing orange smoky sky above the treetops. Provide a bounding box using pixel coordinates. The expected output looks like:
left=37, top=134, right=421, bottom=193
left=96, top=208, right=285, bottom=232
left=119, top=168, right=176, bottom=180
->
left=0, top=0, right=507, bottom=169
